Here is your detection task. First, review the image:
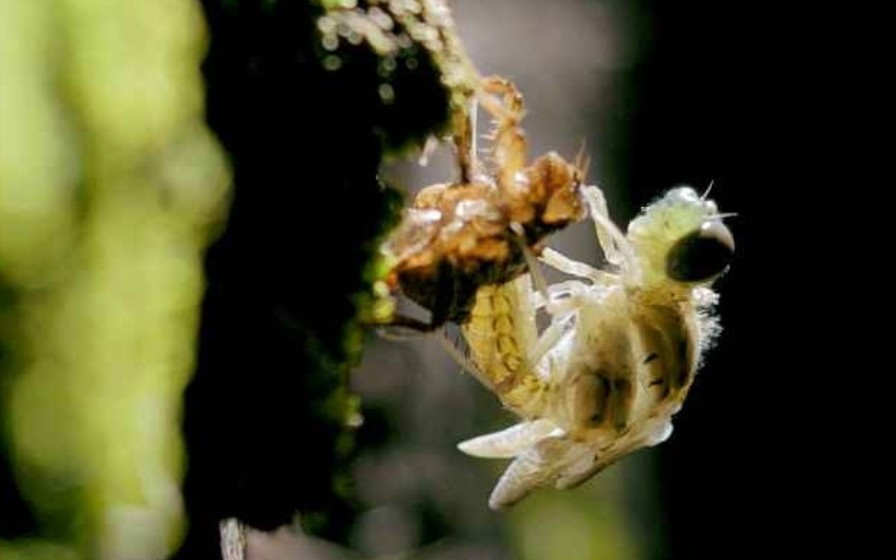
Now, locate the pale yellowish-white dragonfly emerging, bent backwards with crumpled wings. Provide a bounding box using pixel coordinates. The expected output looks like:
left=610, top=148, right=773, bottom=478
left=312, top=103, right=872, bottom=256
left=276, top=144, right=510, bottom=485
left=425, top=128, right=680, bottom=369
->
left=459, top=187, right=734, bottom=509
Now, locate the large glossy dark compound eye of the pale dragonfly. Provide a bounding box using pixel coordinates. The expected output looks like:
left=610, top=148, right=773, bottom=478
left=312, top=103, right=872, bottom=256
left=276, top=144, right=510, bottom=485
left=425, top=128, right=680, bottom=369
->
left=666, top=220, right=734, bottom=282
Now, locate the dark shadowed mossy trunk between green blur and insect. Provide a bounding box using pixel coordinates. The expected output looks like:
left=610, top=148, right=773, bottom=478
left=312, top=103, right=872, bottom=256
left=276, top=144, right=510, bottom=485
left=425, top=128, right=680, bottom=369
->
left=172, top=0, right=473, bottom=559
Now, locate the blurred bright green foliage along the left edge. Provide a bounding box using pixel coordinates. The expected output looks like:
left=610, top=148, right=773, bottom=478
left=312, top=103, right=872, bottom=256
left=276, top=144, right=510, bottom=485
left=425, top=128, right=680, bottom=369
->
left=0, top=0, right=229, bottom=559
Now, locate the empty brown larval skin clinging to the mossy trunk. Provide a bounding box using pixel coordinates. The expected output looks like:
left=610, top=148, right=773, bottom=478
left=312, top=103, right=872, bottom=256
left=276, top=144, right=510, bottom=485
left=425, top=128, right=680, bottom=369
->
left=384, top=76, right=587, bottom=331
